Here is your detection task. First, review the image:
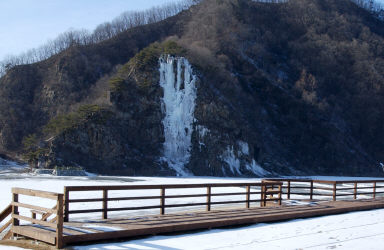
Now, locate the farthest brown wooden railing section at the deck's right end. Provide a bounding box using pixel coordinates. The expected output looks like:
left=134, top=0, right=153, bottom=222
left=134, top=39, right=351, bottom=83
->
left=268, top=178, right=384, bottom=201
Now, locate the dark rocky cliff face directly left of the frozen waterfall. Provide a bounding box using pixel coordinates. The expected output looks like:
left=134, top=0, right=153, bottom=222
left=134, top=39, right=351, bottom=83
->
left=49, top=75, right=171, bottom=175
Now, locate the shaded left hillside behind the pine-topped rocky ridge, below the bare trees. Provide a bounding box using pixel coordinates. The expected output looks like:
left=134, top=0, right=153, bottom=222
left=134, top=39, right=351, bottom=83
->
left=0, top=11, right=187, bottom=153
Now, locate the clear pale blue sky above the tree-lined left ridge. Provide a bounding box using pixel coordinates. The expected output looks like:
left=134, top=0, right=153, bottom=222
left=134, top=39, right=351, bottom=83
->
left=0, top=0, right=172, bottom=61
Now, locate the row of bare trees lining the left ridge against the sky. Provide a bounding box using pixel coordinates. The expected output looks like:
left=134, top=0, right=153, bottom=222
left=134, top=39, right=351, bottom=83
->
left=0, top=0, right=201, bottom=77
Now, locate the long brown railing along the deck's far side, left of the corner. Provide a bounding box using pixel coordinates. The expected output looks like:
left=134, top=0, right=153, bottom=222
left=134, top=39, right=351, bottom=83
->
left=64, top=181, right=282, bottom=221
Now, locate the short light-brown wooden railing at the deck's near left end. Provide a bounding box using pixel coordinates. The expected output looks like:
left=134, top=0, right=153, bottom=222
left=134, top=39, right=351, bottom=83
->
left=11, top=188, right=63, bottom=248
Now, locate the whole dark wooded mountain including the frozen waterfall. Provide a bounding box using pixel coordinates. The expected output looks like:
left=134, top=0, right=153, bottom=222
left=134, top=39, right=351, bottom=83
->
left=0, top=0, right=384, bottom=176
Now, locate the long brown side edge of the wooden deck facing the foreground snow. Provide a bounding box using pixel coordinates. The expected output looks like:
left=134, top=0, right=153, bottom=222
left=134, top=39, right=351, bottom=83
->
left=64, top=203, right=384, bottom=244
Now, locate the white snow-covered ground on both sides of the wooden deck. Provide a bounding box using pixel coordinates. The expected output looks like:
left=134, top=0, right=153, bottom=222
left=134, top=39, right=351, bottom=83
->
left=0, top=162, right=384, bottom=250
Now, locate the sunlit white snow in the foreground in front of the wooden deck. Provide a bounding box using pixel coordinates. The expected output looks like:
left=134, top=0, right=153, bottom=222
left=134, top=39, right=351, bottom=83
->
left=75, top=209, right=384, bottom=250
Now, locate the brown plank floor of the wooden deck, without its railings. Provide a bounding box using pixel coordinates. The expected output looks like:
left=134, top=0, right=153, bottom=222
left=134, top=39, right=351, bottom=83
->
left=12, top=198, right=384, bottom=245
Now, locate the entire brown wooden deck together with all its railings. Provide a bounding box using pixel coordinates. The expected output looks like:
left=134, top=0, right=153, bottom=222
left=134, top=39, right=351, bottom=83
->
left=0, top=179, right=384, bottom=248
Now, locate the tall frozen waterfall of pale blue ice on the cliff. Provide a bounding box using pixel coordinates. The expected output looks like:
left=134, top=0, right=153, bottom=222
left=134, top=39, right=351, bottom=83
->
left=159, top=55, right=196, bottom=176
